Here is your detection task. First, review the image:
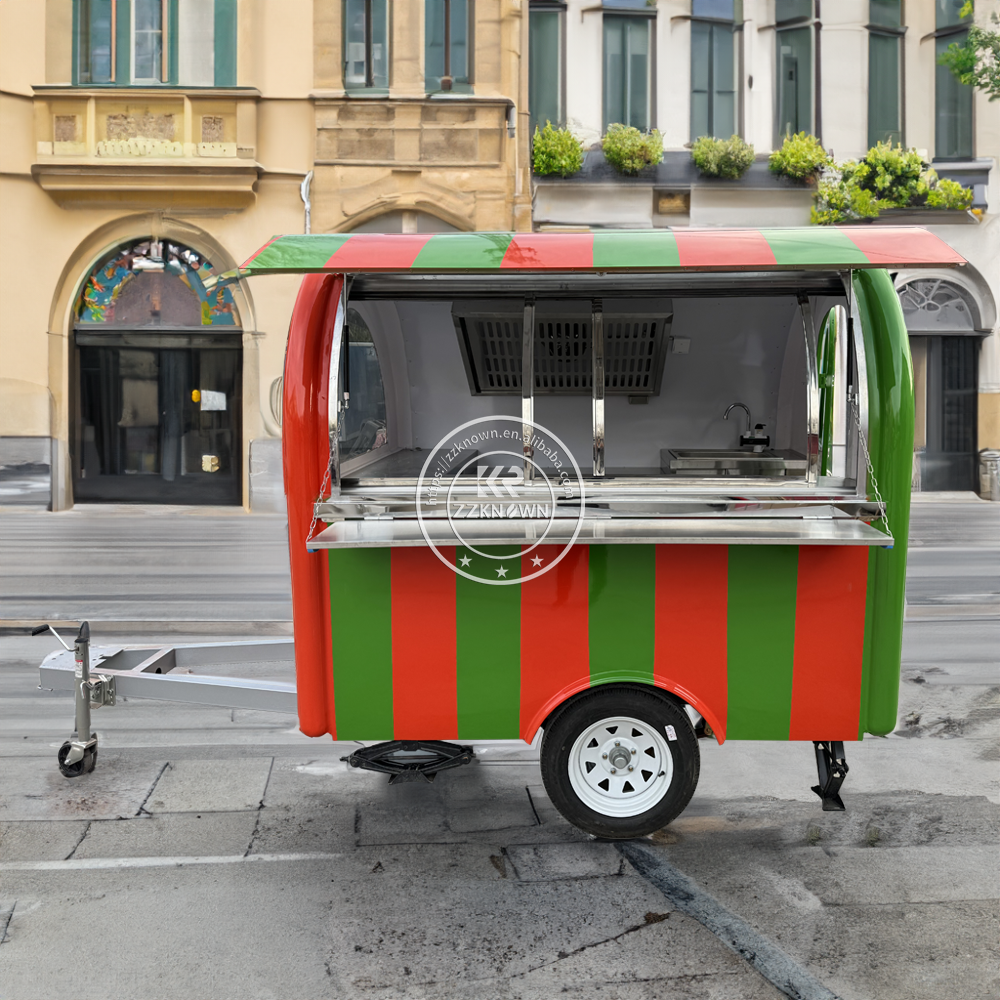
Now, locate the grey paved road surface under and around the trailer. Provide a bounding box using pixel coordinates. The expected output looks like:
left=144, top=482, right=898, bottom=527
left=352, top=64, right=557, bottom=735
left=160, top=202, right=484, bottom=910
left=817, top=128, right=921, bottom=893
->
left=0, top=503, right=1000, bottom=1000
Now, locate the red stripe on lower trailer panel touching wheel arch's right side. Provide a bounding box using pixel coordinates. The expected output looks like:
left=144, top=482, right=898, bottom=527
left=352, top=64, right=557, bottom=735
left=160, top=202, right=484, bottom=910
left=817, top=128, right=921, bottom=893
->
left=653, top=545, right=729, bottom=743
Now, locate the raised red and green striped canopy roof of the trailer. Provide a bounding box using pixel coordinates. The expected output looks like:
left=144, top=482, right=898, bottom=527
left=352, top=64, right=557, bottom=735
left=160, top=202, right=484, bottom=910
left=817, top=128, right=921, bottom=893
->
left=240, top=225, right=965, bottom=275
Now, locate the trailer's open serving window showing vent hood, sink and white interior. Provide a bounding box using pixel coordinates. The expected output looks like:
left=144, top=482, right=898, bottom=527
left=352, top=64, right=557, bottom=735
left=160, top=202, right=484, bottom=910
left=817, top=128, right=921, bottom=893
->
left=340, top=275, right=856, bottom=494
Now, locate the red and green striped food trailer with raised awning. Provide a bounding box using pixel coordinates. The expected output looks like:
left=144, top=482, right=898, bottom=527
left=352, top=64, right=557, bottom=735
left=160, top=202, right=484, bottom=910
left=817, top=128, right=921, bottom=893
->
left=41, top=226, right=964, bottom=838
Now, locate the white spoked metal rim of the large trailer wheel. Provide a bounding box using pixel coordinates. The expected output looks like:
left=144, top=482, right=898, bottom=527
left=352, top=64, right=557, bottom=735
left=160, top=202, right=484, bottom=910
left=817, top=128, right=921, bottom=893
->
left=569, top=716, right=674, bottom=817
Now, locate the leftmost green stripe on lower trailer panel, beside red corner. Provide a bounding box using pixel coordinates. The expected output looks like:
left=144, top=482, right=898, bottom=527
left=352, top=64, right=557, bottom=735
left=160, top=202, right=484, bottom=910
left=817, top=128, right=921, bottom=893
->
left=326, top=549, right=392, bottom=740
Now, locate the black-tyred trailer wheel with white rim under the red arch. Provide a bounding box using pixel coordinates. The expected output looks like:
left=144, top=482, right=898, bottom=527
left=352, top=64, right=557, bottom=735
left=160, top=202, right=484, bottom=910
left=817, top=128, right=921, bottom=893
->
left=541, top=684, right=700, bottom=840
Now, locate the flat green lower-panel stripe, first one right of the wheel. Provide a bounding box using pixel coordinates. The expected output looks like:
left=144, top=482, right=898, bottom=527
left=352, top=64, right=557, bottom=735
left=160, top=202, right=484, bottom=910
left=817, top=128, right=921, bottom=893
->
left=726, top=545, right=796, bottom=740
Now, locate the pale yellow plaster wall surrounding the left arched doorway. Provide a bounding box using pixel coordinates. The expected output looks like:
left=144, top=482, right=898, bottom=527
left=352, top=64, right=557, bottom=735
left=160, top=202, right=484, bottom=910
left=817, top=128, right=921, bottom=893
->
left=0, top=0, right=315, bottom=508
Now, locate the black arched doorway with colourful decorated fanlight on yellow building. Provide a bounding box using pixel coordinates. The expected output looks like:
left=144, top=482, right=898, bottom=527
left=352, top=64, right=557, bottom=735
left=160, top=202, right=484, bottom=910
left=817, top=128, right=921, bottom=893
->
left=70, top=238, right=243, bottom=504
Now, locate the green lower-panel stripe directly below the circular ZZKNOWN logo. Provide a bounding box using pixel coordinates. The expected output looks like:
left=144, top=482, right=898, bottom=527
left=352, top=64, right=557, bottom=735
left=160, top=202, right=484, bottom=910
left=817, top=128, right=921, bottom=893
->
left=455, top=546, right=521, bottom=740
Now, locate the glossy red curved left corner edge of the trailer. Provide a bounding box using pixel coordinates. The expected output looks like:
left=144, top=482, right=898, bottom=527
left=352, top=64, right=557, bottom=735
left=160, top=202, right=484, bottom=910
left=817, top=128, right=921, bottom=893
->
left=281, top=274, right=343, bottom=739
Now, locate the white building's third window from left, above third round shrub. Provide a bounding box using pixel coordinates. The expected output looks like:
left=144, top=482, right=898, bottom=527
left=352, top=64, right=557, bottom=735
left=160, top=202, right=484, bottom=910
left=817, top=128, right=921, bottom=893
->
left=691, top=0, right=743, bottom=139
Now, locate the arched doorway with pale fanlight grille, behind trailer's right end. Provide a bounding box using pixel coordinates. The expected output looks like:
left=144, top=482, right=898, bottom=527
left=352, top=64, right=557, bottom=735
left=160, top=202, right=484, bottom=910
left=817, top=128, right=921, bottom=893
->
left=897, top=277, right=988, bottom=490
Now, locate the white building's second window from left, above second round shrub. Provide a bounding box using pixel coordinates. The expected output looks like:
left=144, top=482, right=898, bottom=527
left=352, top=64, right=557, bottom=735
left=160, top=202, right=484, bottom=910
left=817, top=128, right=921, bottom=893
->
left=604, top=13, right=653, bottom=132
